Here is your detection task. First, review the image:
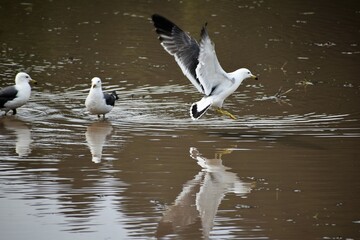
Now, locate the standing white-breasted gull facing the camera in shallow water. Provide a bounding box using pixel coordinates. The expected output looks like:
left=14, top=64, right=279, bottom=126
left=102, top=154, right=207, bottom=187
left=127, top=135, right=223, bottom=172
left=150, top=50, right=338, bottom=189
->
left=85, top=77, right=119, bottom=119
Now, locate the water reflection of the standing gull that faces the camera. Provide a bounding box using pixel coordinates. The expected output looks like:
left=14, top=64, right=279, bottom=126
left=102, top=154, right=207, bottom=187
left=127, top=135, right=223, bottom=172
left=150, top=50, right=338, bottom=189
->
left=85, top=121, right=113, bottom=163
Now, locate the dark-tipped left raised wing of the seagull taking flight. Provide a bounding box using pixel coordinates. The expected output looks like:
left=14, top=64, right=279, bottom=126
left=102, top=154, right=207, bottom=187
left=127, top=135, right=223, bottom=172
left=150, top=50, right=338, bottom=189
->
left=152, top=14, right=204, bottom=93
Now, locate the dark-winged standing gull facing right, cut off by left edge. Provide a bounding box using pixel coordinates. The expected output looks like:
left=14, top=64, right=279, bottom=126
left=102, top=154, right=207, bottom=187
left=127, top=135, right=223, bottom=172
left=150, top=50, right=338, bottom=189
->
left=0, top=72, right=36, bottom=115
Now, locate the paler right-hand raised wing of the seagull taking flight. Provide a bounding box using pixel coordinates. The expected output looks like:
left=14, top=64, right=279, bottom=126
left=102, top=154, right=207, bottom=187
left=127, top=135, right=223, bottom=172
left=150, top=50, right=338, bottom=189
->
left=195, top=25, right=231, bottom=96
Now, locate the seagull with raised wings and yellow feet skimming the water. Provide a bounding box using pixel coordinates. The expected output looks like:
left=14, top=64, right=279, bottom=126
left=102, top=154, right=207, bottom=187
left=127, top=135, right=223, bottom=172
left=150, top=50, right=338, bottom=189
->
left=152, top=14, right=258, bottom=120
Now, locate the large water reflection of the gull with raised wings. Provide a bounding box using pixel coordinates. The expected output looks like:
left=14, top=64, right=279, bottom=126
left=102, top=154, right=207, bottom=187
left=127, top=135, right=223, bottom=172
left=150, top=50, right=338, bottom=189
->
left=156, top=147, right=254, bottom=239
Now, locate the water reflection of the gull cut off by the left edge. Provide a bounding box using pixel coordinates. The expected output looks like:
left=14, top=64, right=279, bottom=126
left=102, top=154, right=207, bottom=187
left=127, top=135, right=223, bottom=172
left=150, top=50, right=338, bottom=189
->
left=0, top=116, right=32, bottom=157
